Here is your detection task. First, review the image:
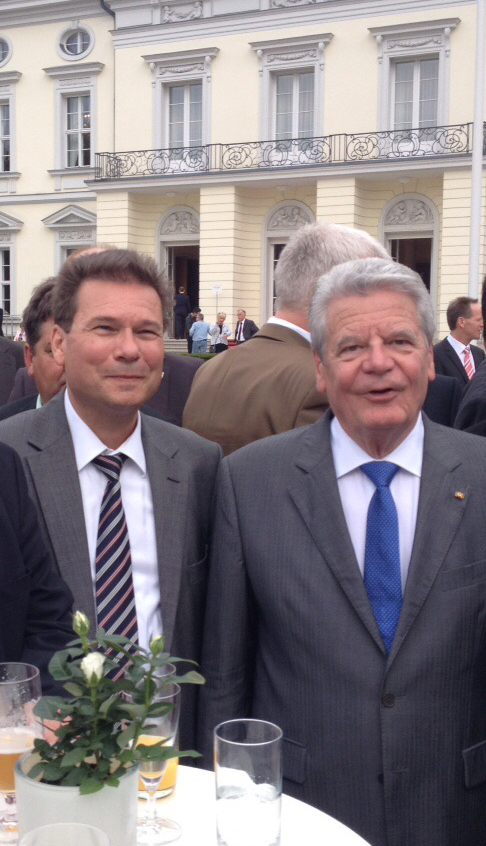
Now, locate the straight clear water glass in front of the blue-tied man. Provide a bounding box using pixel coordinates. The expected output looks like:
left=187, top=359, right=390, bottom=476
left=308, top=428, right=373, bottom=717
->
left=214, top=720, right=282, bottom=846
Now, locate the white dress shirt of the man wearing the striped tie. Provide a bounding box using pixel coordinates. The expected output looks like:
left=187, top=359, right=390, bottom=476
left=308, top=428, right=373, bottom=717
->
left=64, top=390, right=162, bottom=647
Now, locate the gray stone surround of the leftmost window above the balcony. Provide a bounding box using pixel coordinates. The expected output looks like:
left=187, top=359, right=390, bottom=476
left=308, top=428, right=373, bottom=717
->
left=143, top=47, right=219, bottom=150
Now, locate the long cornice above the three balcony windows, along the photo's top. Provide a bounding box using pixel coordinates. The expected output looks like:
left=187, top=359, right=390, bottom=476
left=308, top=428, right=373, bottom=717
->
left=111, top=0, right=475, bottom=48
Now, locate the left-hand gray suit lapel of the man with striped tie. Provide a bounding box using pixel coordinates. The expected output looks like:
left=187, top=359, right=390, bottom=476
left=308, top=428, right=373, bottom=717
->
left=21, top=392, right=95, bottom=622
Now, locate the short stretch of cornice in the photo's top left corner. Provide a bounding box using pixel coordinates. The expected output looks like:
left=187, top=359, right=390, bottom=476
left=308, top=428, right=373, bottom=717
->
left=0, top=0, right=106, bottom=29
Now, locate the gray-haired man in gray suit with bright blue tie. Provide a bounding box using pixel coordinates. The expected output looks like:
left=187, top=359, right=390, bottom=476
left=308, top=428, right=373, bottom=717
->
left=199, top=259, right=486, bottom=846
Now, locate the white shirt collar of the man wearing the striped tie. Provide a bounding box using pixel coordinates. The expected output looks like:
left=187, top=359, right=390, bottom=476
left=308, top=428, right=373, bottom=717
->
left=64, top=389, right=147, bottom=476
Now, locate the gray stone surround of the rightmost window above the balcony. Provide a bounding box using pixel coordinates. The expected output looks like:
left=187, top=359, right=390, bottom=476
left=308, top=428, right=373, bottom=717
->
left=369, top=18, right=460, bottom=132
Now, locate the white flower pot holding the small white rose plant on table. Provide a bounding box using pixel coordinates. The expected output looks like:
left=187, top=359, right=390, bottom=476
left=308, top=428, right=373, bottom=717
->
left=15, top=752, right=138, bottom=846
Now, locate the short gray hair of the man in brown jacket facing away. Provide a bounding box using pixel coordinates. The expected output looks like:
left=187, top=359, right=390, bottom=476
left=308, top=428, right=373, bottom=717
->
left=275, top=223, right=389, bottom=311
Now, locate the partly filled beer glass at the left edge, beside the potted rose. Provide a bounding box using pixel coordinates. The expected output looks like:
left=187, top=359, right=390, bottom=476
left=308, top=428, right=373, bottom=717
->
left=0, top=663, right=43, bottom=843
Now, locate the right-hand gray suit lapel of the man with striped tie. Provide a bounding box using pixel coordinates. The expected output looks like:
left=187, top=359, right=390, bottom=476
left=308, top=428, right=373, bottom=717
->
left=142, top=414, right=189, bottom=648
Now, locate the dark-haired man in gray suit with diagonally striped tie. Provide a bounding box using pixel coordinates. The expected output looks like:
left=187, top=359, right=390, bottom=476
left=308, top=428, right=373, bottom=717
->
left=0, top=250, right=220, bottom=745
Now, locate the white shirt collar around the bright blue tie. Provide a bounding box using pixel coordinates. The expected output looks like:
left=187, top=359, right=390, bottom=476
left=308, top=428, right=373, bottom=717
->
left=331, top=414, right=424, bottom=479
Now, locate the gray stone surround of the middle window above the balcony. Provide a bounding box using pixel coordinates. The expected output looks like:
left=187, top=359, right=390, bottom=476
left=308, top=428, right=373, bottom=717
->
left=250, top=32, right=333, bottom=141
